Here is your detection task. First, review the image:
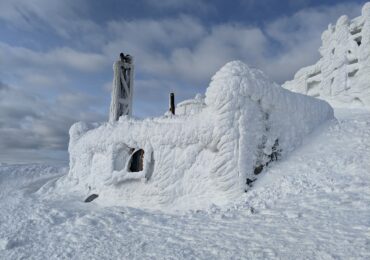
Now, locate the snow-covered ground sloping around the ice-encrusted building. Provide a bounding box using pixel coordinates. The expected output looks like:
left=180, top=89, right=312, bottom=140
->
left=0, top=106, right=370, bottom=259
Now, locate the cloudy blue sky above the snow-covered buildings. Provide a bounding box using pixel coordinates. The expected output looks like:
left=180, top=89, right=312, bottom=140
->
left=0, top=0, right=365, bottom=163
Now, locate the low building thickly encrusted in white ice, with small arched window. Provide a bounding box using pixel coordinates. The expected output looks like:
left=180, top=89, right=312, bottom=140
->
left=59, top=61, right=333, bottom=208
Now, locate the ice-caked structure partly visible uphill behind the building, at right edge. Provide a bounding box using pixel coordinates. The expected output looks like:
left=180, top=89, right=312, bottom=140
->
left=283, top=3, right=370, bottom=106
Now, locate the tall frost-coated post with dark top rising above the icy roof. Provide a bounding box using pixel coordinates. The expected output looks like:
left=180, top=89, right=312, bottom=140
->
left=109, top=53, right=134, bottom=122
